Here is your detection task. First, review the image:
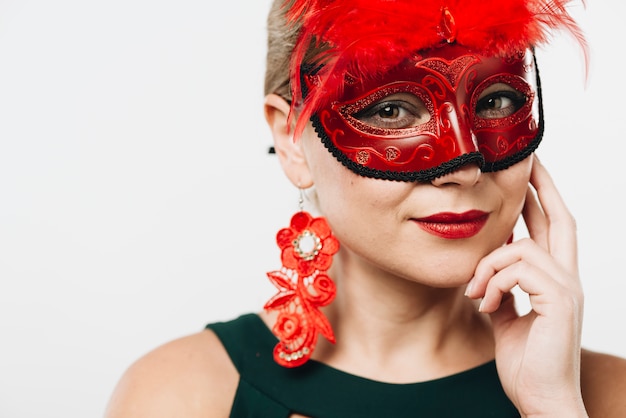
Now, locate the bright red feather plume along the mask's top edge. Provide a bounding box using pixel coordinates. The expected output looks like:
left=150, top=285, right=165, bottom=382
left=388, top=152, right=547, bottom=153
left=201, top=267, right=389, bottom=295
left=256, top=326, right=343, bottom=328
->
left=285, top=0, right=587, bottom=137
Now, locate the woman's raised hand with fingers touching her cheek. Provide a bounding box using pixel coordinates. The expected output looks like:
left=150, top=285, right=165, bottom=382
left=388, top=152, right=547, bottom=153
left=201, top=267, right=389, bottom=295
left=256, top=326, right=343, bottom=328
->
left=467, top=158, right=587, bottom=417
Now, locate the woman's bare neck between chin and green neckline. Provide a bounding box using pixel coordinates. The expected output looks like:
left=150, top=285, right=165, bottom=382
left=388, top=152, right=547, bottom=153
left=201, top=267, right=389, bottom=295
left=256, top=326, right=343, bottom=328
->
left=315, top=250, right=494, bottom=383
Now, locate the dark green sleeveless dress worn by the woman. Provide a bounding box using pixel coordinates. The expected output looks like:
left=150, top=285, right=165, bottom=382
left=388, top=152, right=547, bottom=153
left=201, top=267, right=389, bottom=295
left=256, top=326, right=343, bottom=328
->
left=207, top=314, right=520, bottom=418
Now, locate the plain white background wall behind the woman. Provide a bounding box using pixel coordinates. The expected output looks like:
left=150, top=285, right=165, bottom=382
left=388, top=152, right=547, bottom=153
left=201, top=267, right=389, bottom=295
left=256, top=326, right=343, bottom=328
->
left=0, top=0, right=626, bottom=418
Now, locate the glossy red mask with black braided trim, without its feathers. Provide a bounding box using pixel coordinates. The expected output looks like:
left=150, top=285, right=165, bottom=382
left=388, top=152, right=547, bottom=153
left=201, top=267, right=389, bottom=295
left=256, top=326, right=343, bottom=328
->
left=306, top=45, right=542, bottom=181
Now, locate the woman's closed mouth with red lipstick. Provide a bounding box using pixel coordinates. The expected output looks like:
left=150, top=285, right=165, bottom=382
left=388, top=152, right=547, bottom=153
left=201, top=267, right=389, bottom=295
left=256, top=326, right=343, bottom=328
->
left=413, top=210, right=489, bottom=239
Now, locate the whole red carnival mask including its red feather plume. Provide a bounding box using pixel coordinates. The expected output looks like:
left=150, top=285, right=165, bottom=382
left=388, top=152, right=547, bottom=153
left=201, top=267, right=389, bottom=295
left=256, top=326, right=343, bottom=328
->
left=286, top=0, right=586, bottom=181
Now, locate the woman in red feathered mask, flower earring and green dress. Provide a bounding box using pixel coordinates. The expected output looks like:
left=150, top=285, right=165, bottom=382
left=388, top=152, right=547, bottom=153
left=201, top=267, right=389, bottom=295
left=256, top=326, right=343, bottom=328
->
left=107, top=0, right=626, bottom=418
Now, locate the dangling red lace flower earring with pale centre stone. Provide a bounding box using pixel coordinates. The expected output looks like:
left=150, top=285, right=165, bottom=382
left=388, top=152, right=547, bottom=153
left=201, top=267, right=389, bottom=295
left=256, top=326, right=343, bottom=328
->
left=265, top=191, right=339, bottom=367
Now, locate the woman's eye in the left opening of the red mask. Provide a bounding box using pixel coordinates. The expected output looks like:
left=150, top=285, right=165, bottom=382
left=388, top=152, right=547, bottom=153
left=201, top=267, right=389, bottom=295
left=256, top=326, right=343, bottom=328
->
left=353, top=94, right=430, bottom=129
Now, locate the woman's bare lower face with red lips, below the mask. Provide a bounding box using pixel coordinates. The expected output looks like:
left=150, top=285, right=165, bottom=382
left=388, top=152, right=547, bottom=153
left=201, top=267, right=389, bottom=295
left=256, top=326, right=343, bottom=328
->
left=301, top=127, right=533, bottom=287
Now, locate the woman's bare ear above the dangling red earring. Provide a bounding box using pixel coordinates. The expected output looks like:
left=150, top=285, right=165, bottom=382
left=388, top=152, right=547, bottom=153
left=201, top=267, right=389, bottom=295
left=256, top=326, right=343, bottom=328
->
left=264, top=94, right=313, bottom=189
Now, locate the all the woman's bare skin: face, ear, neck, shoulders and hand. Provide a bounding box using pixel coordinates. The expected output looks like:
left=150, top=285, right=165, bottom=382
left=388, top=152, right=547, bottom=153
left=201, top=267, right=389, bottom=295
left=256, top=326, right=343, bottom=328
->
left=105, top=95, right=626, bottom=418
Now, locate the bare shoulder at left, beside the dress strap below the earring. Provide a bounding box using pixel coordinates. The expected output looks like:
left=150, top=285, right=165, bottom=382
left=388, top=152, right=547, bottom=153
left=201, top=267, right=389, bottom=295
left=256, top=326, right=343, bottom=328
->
left=105, top=330, right=238, bottom=418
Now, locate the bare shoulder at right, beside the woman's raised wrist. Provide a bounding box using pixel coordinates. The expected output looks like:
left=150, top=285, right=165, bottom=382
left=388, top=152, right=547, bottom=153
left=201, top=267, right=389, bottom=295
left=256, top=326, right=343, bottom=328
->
left=581, top=350, right=626, bottom=418
